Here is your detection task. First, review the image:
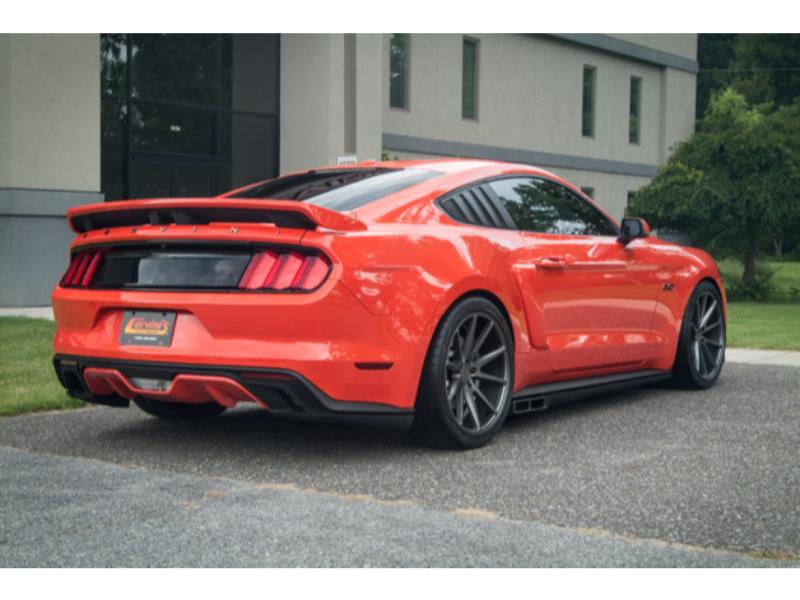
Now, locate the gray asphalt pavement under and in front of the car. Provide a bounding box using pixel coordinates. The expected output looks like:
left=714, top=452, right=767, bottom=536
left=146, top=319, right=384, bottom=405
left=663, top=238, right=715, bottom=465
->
left=0, top=364, right=800, bottom=566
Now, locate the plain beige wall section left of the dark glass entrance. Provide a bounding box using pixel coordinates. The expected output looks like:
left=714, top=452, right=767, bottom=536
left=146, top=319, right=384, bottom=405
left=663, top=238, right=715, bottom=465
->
left=0, top=34, right=100, bottom=192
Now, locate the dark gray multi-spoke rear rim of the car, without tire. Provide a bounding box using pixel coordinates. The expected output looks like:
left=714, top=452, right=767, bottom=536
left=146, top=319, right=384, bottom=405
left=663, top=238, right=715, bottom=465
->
left=444, top=313, right=511, bottom=434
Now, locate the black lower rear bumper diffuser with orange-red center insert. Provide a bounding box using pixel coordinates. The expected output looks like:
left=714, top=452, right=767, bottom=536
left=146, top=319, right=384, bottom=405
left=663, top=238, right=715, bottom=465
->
left=53, top=354, right=414, bottom=428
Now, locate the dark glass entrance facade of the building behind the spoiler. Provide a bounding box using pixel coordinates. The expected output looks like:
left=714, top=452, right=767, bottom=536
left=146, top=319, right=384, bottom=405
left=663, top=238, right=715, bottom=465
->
left=101, top=34, right=279, bottom=200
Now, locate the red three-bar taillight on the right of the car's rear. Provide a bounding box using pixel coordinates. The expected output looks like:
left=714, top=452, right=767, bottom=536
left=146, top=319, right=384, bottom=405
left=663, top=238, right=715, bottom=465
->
left=239, top=250, right=331, bottom=291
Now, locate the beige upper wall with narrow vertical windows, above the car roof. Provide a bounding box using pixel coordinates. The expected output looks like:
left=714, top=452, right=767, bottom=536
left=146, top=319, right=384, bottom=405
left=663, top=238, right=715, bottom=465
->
left=384, top=34, right=693, bottom=165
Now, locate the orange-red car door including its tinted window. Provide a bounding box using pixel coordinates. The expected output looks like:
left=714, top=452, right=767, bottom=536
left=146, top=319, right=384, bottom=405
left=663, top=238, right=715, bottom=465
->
left=489, top=177, right=661, bottom=372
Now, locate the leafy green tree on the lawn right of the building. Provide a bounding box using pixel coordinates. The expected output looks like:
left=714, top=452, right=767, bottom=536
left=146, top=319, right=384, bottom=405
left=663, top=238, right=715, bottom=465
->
left=628, top=88, right=800, bottom=285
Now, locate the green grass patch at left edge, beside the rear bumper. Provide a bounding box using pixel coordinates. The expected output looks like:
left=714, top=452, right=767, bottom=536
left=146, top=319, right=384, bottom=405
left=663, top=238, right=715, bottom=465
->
left=0, top=317, right=83, bottom=416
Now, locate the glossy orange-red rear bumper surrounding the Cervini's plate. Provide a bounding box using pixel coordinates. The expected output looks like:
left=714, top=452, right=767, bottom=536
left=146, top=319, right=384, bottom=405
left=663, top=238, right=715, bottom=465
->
left=53, top=280, right=426, bottom=409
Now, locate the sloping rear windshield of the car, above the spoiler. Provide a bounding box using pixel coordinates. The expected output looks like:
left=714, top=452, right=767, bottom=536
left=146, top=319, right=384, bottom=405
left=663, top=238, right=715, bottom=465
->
left=232, top=169, right=441, bottom=211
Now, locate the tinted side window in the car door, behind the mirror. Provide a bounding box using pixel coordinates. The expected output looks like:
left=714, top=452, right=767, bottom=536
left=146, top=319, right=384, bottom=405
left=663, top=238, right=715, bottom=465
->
left=489, top=177, right=616, bottom=235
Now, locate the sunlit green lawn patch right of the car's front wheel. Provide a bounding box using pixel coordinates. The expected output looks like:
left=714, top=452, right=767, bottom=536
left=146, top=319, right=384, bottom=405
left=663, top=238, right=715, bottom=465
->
left=728, top=302, right=800, bottom=350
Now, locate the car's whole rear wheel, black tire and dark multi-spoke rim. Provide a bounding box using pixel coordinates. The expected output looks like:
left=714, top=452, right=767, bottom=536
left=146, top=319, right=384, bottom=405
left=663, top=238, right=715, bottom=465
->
left=414, top=297, right=514, bottom=448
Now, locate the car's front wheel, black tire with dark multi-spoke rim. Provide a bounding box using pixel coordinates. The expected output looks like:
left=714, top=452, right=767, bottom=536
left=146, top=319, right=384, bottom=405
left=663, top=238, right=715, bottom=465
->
left=672, top=281, right=726, bottom=390
